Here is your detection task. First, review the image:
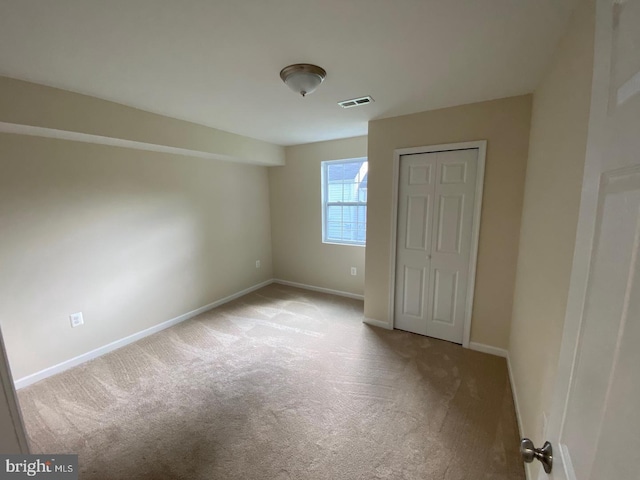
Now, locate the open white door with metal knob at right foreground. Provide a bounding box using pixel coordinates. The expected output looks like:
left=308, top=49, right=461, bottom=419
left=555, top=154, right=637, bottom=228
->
left=540, top=0, right=640, bottom=480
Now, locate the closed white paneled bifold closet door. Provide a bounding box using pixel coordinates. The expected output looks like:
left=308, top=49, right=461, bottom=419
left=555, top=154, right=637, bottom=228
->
left=394, top=148, right=478, bottom=343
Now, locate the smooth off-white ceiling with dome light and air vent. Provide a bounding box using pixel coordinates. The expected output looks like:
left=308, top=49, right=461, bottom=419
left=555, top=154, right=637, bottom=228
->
left=0, top=0, right=577, bottom=145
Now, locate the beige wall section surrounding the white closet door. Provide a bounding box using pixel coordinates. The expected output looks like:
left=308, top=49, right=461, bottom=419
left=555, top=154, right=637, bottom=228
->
left=365, top=95, right=531, bottom=349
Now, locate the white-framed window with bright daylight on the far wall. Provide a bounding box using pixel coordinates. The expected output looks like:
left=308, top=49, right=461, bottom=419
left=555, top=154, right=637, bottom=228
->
left=322, top=158, right=369, bottom=245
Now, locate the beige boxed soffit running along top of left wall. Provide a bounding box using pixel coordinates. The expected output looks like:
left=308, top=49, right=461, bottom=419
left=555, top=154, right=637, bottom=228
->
left=0, top=76, right=284, bottom=165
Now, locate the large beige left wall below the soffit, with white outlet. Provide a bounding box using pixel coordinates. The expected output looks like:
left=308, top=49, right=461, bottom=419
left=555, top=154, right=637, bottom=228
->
left=0, top=134, right=273, bottom=379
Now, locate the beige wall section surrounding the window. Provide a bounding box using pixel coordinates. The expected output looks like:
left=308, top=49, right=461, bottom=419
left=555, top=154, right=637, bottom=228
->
left=269, top=137, right=367, bottom=295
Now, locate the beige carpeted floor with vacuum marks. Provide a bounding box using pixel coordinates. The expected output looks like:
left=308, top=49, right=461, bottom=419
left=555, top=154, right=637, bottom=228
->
left=19, top=285, right=524, bottom=480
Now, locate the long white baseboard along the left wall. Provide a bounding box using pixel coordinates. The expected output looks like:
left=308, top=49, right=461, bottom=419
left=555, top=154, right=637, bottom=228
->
left=14, top=280, right=273, bottom=390
